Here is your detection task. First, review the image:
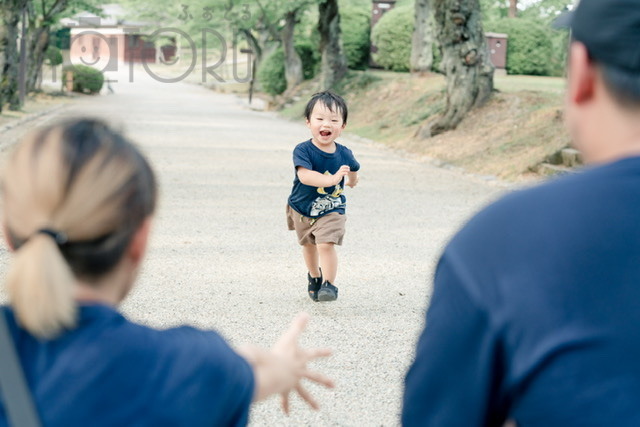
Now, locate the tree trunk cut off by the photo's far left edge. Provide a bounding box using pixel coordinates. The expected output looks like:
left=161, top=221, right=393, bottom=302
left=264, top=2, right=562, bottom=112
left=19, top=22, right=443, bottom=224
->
left=0, top=1, right=22, bottom=110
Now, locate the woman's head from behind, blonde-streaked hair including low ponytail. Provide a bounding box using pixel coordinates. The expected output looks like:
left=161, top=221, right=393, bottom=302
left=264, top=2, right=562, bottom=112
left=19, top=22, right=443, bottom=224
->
left=2, top=119, right=157, bottom=339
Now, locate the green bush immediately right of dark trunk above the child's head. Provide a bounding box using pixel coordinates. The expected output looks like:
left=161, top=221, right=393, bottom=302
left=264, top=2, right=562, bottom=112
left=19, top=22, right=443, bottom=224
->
left=340, top=3, right=371, bottom=70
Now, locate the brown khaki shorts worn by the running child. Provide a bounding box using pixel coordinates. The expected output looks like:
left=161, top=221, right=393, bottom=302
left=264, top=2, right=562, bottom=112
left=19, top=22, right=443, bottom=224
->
left=287, top=204, right=347, bottom=246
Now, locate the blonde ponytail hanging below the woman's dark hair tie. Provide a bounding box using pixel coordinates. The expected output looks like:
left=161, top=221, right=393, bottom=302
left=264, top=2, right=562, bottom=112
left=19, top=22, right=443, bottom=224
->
left=6, top=233, right=77, bottom=339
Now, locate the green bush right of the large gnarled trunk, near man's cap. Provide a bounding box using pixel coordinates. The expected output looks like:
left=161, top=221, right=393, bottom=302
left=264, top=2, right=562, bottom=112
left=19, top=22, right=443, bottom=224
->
left=485, top=18, right=554, bottom=76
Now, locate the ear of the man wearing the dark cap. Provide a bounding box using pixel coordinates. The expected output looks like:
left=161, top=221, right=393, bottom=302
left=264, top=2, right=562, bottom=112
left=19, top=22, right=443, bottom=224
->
left=568, top=42, right=597, bottom=105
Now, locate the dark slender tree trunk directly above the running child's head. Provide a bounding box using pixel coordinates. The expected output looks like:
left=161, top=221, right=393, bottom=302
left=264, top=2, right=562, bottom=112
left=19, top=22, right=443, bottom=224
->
left=318, top=0, right=347, bottom=89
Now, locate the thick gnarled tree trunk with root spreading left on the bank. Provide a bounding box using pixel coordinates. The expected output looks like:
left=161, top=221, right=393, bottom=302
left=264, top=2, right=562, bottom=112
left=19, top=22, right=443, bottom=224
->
left=420, top=0, right=494, bottom=137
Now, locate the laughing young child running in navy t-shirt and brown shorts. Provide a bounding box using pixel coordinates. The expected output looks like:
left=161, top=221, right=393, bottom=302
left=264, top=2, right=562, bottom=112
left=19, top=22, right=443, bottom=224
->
left=287, top=91, right=360, bottom=301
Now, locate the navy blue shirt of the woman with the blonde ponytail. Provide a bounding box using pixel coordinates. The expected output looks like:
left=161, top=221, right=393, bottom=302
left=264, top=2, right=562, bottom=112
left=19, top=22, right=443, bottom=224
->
left=0, top=305, right=254, bottom=427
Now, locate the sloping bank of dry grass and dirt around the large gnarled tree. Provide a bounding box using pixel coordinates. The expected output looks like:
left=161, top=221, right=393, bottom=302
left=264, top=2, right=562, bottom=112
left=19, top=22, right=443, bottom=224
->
left=283, top=72, right=569, bottom=181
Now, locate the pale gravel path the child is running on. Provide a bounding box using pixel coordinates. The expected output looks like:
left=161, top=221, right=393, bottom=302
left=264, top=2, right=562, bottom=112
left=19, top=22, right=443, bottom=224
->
left=0, top=71, right=504, bottom=426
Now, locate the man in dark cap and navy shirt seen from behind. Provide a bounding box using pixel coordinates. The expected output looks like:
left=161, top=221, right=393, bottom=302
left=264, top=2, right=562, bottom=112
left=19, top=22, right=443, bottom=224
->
left=402, top=0, right=640, bottom=427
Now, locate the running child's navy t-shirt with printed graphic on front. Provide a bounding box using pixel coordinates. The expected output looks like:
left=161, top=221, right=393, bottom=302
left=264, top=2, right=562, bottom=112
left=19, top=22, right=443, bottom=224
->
left=289, top=140, right=360, bottom=218
